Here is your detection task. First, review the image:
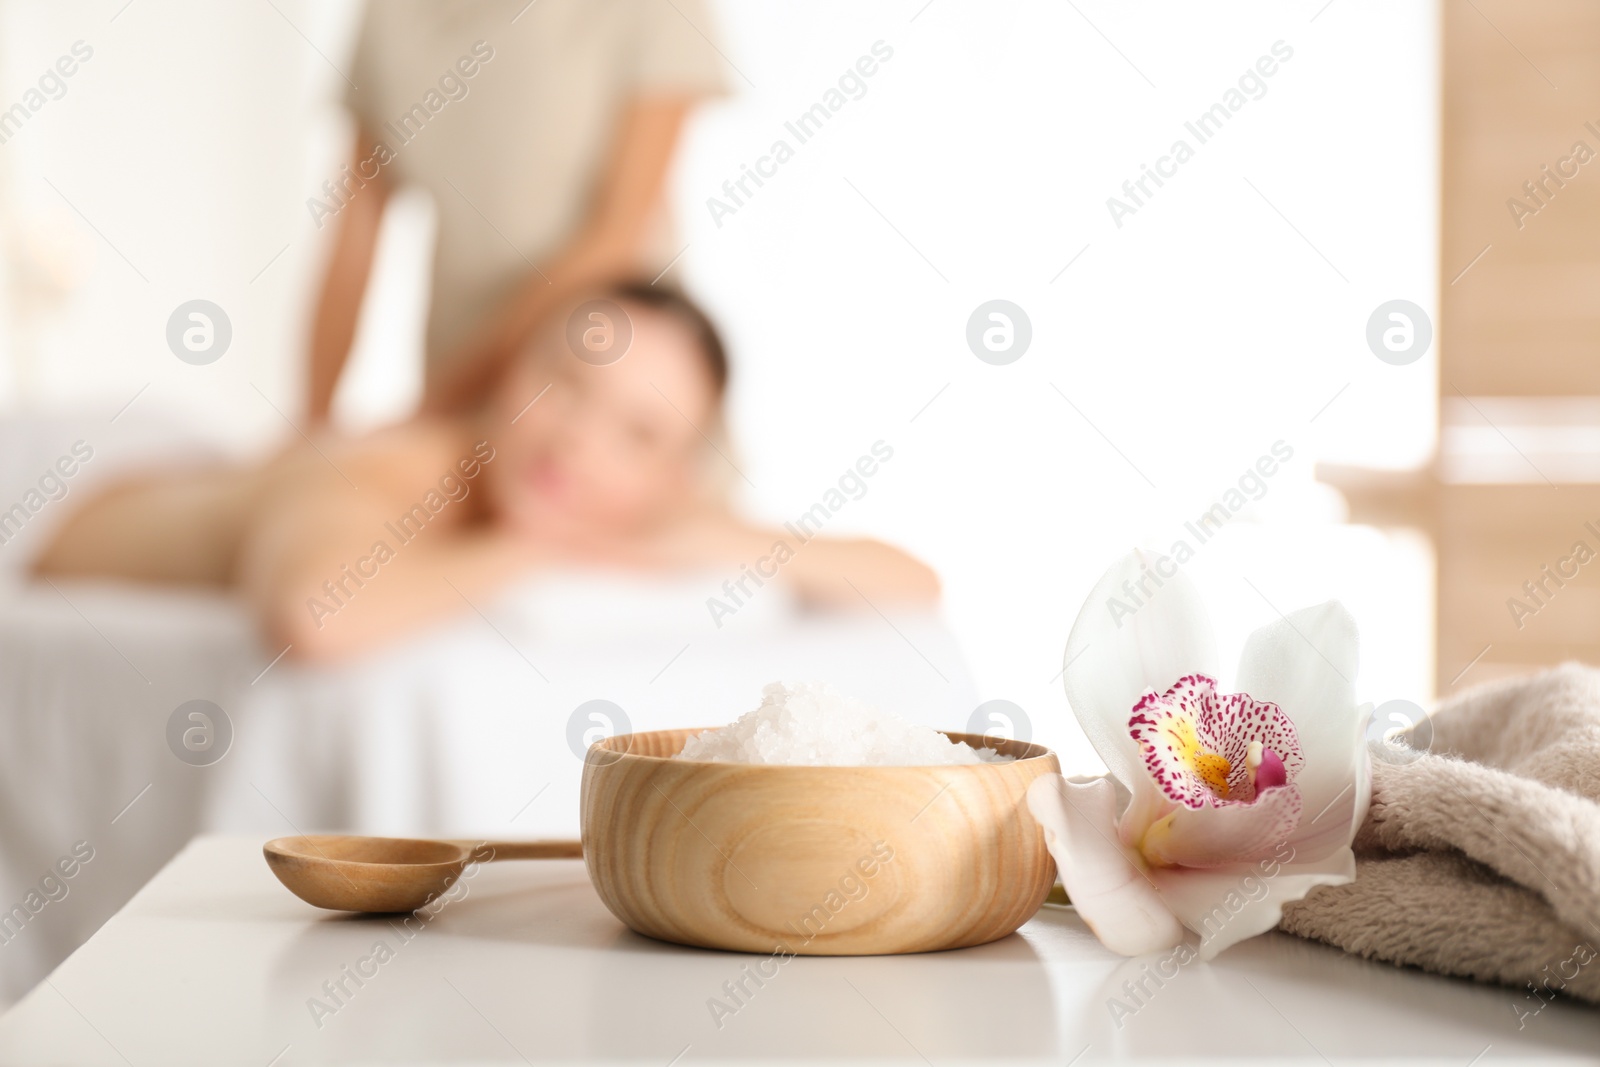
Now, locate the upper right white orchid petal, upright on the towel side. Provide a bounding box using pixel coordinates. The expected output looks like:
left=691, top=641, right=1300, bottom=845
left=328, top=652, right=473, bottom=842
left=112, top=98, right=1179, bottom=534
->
left=1237, top=600, right=1365, bottom=846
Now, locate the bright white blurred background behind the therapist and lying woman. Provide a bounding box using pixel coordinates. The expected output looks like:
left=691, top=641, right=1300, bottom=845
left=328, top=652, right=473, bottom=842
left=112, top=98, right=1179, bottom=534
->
left=0, top=0, right=1440, bottom=766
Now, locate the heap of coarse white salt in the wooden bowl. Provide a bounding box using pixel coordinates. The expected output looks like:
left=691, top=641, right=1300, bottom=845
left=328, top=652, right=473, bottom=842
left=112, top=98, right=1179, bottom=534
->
left=677, top=681, right=1013, bottom=766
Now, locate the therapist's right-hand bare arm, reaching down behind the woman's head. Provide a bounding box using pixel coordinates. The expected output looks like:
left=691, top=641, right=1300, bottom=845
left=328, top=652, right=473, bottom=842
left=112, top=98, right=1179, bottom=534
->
left=424, top=96, right=694, bottom=413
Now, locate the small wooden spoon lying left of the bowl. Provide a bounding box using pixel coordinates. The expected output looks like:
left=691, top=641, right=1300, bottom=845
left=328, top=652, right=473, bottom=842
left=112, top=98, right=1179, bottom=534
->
left=261, top=833, right=584, bottom=912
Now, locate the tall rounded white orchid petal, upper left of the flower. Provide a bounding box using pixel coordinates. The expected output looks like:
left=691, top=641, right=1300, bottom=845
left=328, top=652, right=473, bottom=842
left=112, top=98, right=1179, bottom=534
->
left=1062, top=552, right=1216, bottom=787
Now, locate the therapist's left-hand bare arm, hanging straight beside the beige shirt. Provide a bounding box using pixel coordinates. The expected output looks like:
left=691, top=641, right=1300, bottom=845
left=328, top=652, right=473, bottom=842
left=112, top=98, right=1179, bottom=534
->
left=307, top=130, right=389, bottom=426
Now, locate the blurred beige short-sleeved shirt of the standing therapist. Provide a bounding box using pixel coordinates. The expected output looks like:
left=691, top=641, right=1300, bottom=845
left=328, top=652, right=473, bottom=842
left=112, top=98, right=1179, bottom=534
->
left=346, top=0, right=723, bottom=381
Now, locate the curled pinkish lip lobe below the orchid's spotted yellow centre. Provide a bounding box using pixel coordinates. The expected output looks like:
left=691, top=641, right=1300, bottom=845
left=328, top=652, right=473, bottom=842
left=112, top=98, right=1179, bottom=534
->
left=1142, top=785, right=1299, bottom=867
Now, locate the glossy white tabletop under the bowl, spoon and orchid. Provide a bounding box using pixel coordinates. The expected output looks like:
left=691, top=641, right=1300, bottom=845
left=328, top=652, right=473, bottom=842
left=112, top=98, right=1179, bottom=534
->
left=0, top=837, right=1600, bottom=1067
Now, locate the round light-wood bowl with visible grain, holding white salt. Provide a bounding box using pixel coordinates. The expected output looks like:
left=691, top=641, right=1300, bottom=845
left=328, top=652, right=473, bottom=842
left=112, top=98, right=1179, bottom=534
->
left=582, top=729, right=1061, bottom=955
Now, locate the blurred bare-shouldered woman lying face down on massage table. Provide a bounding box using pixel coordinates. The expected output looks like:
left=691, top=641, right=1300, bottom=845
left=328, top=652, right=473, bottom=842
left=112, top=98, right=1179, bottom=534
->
left=35, top=285, right=938, bottom=659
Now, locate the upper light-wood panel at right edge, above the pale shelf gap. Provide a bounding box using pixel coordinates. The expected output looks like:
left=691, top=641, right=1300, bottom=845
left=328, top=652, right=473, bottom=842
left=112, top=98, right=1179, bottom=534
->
left=1438, top=0, right=1600, bottom=395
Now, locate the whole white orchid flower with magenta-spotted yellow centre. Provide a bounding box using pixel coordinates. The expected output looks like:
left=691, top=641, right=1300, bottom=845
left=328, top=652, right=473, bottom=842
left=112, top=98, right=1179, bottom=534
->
left=1027, top=552, right=1371, bottom=960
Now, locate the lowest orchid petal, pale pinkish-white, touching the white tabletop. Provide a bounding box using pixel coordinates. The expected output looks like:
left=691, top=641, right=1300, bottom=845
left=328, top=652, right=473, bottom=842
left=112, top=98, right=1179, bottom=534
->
left=1150, top=848, right=1355, bottom=960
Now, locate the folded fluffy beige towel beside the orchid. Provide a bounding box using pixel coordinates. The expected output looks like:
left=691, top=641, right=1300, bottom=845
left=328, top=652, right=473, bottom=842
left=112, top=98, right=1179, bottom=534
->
left=1282, top=664, right=1600, bottom=1013
